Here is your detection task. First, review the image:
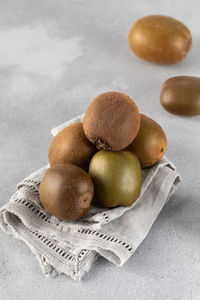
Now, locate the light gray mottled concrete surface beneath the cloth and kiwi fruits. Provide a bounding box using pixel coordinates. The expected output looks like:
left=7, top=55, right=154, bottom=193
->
left=0, top=0, right=200, bottom=300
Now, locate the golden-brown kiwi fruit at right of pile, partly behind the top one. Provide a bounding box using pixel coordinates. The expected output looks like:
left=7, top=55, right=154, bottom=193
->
left=127, top=114, right=167, bottom=168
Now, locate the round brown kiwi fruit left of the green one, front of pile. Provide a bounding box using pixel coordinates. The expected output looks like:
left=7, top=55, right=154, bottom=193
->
left=39, top=164, right=94, bottom=221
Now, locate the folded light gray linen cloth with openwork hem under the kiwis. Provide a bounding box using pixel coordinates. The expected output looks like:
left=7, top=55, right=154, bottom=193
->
left=0, top=115, right=180, bottom=279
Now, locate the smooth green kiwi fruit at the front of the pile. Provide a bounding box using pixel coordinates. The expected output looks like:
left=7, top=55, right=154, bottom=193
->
left=89, top=150, right=142, bottom=207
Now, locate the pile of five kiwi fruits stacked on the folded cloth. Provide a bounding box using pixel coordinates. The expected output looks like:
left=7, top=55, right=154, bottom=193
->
left=39, top=92, right=167, bottom=221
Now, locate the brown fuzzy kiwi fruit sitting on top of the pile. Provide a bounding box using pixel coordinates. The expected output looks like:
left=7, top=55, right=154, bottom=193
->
left=83, top=92, right=140, bottom=151
